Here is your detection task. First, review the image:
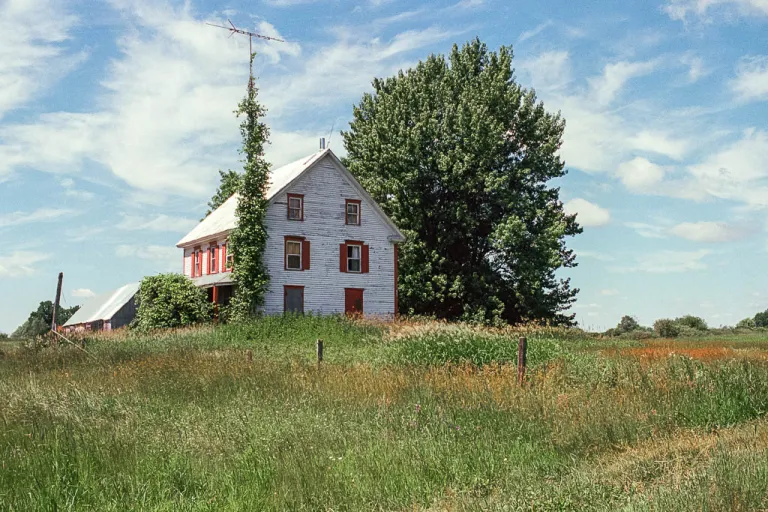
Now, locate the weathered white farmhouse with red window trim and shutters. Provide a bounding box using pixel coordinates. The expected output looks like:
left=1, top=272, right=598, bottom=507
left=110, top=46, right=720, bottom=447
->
left=177, top=145, right=404, bottom=316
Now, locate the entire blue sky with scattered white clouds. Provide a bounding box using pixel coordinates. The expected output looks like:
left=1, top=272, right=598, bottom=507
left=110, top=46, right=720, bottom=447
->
left=0, top=0, right=768, bottom=332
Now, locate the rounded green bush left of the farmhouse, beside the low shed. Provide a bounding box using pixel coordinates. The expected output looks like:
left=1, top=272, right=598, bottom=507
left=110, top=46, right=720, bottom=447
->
left=134, top=274, right=213, bottom=331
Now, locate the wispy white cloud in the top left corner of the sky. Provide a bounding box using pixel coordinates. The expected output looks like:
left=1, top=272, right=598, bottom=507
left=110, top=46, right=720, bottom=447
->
left=0, top=0, right=83, bottom=119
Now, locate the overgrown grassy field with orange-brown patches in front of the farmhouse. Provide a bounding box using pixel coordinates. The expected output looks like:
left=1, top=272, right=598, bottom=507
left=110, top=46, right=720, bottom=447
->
left=0, top=318, right=768, bottom=511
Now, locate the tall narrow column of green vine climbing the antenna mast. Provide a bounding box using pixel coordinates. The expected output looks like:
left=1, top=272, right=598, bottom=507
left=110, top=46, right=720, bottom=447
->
left=229, top=55, right=269, bottom=320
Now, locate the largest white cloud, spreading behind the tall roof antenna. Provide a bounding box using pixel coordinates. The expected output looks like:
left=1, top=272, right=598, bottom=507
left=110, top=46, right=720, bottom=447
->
left=0, top=0, right=455, bottom=198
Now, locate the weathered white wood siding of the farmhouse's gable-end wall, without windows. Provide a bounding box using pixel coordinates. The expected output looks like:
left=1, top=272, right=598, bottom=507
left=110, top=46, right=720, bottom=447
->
left=265, top=158, right=395, bottom=316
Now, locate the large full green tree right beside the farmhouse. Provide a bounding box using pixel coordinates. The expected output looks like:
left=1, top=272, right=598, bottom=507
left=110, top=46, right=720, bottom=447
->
left=343, top=40, right=581, bottom=324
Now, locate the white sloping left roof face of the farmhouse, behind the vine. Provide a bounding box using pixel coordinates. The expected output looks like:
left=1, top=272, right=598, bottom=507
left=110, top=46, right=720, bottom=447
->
left=176, top=149, right=331, bottom=247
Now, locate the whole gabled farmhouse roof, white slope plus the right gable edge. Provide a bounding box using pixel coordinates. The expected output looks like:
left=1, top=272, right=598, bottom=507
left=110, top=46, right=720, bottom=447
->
left=176, top=149, right=405, bottom=247
